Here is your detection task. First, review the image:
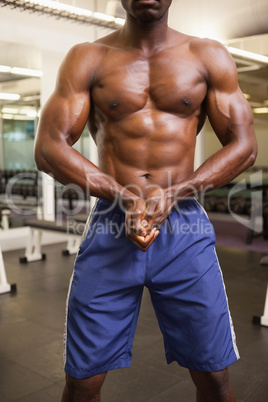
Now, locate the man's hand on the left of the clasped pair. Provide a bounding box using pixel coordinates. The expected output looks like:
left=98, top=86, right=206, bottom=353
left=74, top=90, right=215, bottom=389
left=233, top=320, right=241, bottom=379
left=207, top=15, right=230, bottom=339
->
left=125, top=198, right=159, bottom=251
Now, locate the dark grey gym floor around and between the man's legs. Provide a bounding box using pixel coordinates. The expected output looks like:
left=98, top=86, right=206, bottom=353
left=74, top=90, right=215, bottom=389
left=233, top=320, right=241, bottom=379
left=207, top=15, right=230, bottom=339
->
left=0, top=240, right=268, bottom=402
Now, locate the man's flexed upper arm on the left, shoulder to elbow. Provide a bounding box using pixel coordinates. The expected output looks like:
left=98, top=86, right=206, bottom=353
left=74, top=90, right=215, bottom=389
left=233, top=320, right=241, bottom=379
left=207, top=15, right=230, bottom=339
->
left=36, top=43, right=103, bottom=152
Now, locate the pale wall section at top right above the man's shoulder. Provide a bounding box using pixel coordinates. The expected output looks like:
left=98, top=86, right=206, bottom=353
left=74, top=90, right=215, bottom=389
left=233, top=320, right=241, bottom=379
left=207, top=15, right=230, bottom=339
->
left=170, top=0, right=268, bottom=40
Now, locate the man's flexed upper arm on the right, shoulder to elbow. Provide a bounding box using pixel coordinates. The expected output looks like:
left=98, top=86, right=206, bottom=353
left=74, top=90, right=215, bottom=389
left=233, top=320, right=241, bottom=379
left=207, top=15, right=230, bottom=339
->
left=202, top=41, right=256, bottom=147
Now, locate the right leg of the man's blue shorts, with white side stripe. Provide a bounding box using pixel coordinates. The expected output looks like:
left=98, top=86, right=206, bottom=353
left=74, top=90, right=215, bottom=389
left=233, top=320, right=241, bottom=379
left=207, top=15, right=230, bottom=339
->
left=149, top=199, right=238, bottom=372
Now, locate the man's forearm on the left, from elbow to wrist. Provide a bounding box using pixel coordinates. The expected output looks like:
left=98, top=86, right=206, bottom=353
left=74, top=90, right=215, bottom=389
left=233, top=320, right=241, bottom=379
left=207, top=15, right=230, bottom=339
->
left=35, top=142, right=137, bottom=208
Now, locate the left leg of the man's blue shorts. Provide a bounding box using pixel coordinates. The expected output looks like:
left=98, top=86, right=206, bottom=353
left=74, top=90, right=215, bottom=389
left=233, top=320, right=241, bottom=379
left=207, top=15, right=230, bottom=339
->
left=65, top=203, right=146, bottom=378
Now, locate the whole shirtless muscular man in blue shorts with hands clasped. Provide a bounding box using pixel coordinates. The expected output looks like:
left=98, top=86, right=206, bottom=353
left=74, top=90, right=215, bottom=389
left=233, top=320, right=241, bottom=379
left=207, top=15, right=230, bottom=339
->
left=35, top=0, right=257, bottom=402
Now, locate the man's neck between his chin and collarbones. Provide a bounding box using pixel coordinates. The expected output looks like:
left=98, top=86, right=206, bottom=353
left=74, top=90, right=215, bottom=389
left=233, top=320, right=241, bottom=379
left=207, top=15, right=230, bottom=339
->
left=121, top=14, right=169, bottom=55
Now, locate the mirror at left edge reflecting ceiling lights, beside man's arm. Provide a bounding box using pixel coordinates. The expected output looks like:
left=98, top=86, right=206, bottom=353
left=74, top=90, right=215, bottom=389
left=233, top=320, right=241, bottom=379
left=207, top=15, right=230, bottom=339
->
left=0, top=42, right=42, bottom=171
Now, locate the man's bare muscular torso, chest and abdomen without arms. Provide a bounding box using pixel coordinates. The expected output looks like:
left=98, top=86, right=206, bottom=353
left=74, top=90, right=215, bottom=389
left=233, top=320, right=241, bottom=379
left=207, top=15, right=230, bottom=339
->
left=89, top=32, right=207, bottom=197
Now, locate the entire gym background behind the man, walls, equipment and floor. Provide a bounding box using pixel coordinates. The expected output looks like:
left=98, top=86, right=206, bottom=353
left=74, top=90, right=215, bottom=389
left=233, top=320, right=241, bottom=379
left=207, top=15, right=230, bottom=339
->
left=0, top=0, right=268, bottom=402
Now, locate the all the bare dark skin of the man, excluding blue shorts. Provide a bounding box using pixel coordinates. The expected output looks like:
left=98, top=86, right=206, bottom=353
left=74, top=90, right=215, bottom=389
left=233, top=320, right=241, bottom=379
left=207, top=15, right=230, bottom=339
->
left=35, top=0, right=257, bottom=402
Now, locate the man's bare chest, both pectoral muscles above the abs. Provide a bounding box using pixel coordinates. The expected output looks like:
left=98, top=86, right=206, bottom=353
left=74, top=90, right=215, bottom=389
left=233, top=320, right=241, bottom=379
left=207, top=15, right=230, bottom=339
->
left=92, top=52, right=207, bottom=119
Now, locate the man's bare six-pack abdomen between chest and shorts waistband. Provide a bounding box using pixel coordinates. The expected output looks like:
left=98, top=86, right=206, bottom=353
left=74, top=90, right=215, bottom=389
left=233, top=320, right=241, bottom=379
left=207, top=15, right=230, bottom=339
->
left=96, top=110, right=197, bottom=196
